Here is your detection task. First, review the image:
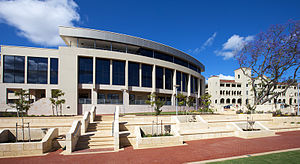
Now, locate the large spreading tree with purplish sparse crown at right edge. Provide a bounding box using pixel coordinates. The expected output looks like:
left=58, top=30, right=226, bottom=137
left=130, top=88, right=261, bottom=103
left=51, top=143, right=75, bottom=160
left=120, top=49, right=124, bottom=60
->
left=236, top=21, right=300, bottom=110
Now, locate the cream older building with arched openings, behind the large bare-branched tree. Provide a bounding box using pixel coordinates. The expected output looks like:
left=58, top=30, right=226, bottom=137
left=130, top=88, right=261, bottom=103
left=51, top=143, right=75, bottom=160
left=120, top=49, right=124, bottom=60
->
left=206, top=68, right=297, bottom=111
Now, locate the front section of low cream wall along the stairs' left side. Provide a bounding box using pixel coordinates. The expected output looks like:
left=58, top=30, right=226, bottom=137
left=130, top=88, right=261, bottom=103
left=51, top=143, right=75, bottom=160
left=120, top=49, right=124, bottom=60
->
left=66, top=120, right=81, bottom=153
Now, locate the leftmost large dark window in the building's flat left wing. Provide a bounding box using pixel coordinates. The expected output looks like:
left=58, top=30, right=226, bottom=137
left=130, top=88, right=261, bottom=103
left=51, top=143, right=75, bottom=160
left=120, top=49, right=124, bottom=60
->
left=3, top=55, right=25, bottom=83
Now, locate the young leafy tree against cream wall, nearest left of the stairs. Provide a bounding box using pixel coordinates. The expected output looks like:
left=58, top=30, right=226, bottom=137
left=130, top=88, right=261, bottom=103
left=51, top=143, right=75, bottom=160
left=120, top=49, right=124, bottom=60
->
left=49, top=89, right=66, bottom=116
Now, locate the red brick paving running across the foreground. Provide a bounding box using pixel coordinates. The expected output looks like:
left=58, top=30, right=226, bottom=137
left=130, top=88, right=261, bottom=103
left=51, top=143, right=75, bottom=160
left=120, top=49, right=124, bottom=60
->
left=0, top=131, right=300, bottom=164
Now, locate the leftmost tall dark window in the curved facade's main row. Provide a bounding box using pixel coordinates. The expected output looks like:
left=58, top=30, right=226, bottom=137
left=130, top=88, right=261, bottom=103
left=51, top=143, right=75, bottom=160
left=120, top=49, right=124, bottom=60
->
left=78, top=57, right=93, bottom=84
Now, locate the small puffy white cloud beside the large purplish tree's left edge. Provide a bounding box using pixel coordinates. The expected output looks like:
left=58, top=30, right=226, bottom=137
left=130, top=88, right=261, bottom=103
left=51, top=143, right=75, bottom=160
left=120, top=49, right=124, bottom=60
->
left=215, top=35, right=254, bottom=60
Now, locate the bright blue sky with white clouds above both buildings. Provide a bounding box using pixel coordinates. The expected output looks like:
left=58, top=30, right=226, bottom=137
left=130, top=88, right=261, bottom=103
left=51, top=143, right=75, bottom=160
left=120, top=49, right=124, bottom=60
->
left=0, top=0, right=300, bottom=78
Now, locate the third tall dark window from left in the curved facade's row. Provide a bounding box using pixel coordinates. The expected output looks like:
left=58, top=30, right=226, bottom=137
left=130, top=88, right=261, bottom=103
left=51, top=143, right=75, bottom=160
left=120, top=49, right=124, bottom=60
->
left=112, top=60, right=125, bottom=85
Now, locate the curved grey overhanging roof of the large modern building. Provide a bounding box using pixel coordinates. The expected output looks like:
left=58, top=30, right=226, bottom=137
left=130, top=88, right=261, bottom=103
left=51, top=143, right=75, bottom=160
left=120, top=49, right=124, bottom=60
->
left=59, top=26, right=205, bottom=72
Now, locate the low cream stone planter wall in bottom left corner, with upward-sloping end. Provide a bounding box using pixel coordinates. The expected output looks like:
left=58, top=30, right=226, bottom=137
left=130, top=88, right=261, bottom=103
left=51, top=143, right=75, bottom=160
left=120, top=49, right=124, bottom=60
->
left=0, top=128, right=58, bottom=157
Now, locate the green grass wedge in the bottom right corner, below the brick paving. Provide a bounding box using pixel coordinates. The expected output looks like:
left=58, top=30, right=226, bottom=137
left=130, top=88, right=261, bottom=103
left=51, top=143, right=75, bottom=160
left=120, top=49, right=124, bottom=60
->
left=211, top=150, right=300, bottom=164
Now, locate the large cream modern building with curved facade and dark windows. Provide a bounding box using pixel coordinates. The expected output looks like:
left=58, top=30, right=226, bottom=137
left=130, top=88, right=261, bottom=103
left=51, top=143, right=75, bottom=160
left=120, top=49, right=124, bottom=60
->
left=0, top=27, right=205, bottom=115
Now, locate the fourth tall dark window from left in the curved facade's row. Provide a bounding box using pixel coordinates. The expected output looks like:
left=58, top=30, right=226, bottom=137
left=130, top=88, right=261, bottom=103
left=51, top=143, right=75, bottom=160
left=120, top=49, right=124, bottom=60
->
left=128, top=62, right=140, bottom=86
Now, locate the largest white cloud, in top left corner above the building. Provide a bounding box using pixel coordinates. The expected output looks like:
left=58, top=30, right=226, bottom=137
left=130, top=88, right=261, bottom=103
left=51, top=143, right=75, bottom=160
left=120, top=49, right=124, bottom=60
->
left=0, top=0, right=80, bottom=46
